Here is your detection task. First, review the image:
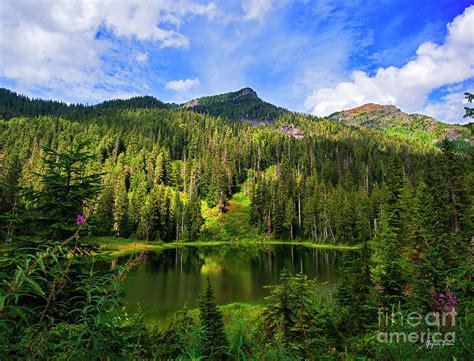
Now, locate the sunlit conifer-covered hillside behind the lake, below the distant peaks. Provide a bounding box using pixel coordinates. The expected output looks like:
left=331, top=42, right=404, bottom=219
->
left=0, top=98, right=466, bottom=244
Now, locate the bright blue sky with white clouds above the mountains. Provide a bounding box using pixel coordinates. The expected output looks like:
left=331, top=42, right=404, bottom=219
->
left=0, top=0, right=474, bottom=123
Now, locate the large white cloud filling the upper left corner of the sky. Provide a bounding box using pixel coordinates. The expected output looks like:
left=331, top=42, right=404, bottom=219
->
left=0, top=0, right=216, bottom=101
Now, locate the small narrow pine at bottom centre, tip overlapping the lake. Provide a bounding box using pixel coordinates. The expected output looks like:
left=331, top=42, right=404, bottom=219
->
left=199, top=277, right=229, bottom=360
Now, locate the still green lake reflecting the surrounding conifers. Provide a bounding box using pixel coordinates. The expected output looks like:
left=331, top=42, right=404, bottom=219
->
left=104, top=244, right=347, bottom=319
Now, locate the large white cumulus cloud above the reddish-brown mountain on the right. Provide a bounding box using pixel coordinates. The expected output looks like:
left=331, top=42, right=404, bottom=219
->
left=305, top=6, right=474, bottom=122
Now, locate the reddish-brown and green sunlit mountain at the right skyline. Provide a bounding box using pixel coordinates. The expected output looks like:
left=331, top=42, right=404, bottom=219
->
left=327, top=103, right=473, bottom=144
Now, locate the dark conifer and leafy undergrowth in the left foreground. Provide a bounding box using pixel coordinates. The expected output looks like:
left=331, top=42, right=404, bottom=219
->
left=0, top=144, right=146, bottom=359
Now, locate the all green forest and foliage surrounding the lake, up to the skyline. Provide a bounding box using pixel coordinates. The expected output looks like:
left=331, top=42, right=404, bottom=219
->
left=0, top=89, right=474, bottom=359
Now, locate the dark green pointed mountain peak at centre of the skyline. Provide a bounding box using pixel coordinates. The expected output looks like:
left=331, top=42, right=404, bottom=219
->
left=182, top=88, right=288, bottom=123
